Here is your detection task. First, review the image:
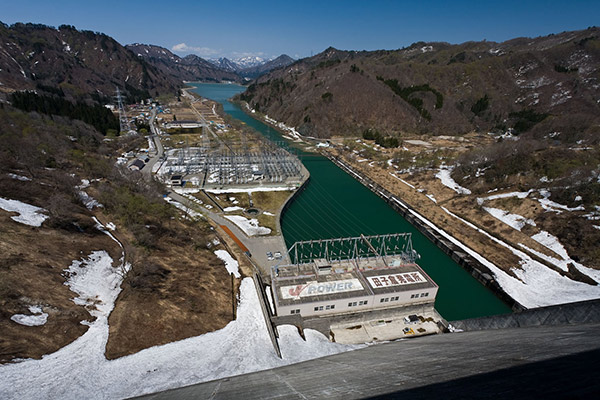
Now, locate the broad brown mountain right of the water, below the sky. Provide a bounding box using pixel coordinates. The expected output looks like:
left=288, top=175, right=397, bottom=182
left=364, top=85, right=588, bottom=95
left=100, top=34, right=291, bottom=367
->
left=240, top=28, right=600, bottom=140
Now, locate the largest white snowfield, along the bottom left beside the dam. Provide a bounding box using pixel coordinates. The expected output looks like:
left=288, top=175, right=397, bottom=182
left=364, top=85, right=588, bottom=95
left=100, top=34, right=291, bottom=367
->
left=0, top=278, right=364, bottom=399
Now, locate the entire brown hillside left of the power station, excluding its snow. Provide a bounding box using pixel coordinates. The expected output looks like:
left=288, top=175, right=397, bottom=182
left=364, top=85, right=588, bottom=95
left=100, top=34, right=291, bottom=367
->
left=0, top=104, right=239, bottom=362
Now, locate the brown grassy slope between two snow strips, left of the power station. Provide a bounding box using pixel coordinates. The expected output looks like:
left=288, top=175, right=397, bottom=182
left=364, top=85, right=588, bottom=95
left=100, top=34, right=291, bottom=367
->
left=106, top=216, right=239, bottom=359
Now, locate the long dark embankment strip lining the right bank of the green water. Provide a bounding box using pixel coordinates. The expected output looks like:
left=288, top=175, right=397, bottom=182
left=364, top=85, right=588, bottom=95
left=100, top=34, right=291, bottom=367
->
left=325, top=154, right=526, bottom=311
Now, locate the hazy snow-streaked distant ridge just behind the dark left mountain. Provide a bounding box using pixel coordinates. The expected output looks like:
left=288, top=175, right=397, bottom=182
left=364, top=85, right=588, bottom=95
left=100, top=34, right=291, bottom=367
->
left=126, top=43, right=240, bottom=82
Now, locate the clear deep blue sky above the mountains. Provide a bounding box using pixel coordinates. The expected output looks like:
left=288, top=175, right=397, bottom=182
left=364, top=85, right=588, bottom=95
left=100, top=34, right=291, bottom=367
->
left=0, top=0, right=600, bottom=58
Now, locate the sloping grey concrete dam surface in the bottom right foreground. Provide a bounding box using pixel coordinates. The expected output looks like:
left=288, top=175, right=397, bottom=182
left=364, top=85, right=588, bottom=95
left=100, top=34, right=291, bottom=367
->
left=136, top=324, right=600, bottom=400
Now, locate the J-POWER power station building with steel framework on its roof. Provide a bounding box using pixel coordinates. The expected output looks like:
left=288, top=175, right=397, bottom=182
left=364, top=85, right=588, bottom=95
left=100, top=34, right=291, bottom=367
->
left=271, top=233, right=438, bottom=317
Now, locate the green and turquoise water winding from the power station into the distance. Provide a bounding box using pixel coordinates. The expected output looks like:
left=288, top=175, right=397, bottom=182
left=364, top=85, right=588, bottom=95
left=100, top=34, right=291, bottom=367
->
left=193, top=83, right=511, bottom=321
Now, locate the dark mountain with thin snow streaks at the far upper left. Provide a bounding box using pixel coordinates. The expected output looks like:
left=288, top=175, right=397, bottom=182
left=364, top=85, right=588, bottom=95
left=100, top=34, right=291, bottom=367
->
left=0, top=23, right=181, bottom=101
